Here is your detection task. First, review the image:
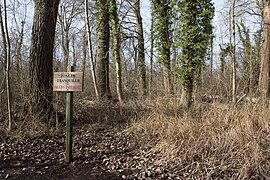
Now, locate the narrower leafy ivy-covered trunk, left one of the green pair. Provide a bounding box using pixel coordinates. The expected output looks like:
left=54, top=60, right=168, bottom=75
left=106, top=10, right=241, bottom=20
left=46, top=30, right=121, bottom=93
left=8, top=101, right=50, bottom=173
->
left=152, top=0, right=173, bottom=95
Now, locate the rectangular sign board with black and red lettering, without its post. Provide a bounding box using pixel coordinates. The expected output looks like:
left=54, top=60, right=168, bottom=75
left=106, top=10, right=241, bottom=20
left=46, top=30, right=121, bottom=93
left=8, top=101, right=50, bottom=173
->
left=53, top=72, right=83, bottom=92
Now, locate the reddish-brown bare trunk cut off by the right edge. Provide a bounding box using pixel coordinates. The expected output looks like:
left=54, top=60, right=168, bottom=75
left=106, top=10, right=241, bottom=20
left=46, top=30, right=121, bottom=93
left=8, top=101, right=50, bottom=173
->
left=260, top=0, right=270, bottom=103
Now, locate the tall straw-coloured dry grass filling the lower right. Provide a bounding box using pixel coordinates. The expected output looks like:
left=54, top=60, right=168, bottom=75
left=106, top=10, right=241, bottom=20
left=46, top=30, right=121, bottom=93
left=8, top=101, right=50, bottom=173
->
left=127, top=102, right=270, bottom=179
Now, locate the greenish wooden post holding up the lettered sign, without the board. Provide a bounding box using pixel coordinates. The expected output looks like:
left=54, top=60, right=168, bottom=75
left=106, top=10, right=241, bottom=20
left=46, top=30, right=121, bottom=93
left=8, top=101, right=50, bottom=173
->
left=66, top=66, right=74, bottom=162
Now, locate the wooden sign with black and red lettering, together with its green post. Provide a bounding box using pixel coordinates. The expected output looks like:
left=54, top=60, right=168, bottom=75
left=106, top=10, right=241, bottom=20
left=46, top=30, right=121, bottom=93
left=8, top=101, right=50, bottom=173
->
left=53, top=66, right=83, bottom=162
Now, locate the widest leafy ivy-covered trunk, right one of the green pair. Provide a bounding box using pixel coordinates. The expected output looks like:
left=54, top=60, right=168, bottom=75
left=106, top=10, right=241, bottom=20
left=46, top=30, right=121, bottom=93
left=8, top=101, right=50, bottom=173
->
left=173, top=0, right=214, bottom=108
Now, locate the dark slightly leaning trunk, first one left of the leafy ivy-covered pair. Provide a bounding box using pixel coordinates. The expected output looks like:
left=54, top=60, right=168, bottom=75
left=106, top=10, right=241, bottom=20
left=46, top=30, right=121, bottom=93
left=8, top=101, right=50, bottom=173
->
left=134, top=0, right=147, bottom=96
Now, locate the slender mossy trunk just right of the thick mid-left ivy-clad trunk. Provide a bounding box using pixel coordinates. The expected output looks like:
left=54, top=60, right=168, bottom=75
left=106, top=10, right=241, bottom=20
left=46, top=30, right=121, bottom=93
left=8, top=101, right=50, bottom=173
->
left=110, top=0, right=123, bottom=103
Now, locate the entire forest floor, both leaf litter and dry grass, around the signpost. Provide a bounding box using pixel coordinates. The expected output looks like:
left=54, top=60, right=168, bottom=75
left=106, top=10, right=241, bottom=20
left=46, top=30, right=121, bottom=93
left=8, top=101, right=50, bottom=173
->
left=0, top=100, right=270, bottom=180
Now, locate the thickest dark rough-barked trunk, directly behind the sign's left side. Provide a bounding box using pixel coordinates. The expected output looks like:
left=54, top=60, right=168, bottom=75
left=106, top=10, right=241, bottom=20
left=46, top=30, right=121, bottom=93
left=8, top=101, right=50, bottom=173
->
left=30, top=0, right=59, bottom=121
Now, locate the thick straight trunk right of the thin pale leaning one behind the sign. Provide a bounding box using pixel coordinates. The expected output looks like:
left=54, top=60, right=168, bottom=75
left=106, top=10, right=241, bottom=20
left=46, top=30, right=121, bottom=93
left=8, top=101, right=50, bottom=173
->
left=96, top=0, right=112, bottom=100
